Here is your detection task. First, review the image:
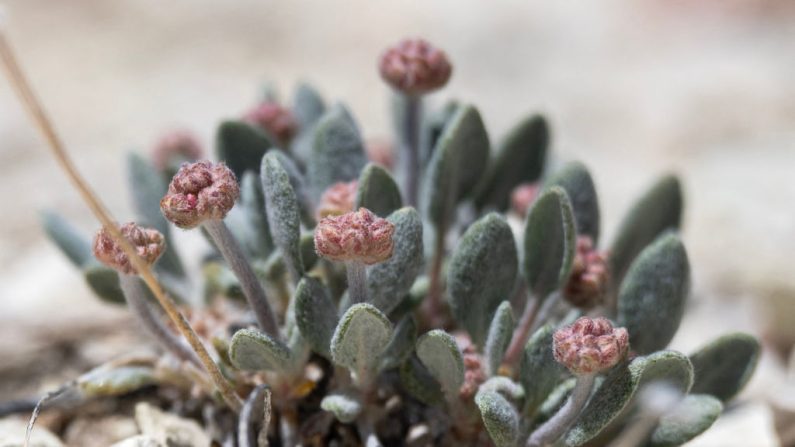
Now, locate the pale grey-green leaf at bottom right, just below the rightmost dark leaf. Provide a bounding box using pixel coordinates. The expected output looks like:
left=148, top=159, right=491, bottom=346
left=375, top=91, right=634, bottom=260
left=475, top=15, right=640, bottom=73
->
left=648, top=394, right=723, bottom=447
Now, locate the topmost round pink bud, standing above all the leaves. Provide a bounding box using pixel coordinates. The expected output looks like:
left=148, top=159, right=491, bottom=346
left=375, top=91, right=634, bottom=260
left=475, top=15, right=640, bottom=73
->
left=378, top=39, right=453, bottom=95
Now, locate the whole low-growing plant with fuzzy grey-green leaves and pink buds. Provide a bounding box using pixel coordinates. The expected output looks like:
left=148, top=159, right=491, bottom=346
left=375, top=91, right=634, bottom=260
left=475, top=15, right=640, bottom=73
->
left=4, top=34, right=759, bottom=447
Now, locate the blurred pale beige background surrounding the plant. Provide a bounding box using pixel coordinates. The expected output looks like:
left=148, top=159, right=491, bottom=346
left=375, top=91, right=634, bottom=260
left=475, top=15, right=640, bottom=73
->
left=0, top=0, right=795, bottom=446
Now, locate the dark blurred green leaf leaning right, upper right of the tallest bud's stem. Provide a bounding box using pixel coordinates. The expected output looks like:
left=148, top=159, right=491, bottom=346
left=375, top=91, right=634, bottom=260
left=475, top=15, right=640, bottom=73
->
left=475, top=115, right=549, bottom=211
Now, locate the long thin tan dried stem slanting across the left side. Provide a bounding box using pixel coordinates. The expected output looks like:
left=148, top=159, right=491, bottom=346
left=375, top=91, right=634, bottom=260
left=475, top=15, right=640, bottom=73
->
left=0, top=28, right=242, bottom=412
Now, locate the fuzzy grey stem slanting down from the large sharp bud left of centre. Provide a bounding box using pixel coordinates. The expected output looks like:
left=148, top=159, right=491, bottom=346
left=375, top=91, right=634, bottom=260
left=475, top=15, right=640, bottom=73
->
left=202, top=219, right=280, bottom=339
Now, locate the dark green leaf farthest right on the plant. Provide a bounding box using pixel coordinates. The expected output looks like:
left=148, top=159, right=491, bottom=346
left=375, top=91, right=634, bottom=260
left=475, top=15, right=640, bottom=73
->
left=690, top=333, right=760, bottom=402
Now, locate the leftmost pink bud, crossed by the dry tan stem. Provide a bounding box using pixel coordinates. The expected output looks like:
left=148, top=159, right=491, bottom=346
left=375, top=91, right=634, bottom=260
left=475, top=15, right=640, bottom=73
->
left=93, top=222, right=166, bottom=275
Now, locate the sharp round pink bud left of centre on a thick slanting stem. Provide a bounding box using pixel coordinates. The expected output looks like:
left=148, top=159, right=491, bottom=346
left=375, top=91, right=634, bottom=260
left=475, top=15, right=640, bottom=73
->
left=160, top=160, right=240, bottom=228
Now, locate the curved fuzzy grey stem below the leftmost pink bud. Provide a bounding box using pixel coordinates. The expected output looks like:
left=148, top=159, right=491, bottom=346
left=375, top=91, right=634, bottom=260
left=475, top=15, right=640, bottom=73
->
left=119, top=273, right=201, bottom=366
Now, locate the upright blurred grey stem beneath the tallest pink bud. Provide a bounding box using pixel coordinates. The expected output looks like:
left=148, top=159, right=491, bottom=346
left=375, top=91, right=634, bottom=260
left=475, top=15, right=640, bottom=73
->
left=401, top=95, right=422, bottom=208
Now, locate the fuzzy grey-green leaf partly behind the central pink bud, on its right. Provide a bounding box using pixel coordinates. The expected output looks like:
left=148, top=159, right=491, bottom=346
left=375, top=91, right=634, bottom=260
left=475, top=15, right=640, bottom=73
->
left=367, top=208, right=424, bottom=315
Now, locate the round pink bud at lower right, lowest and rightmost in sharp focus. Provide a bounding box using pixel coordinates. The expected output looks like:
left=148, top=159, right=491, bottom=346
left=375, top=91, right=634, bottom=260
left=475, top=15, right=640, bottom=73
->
left=553, top=317, right=629, bottom=375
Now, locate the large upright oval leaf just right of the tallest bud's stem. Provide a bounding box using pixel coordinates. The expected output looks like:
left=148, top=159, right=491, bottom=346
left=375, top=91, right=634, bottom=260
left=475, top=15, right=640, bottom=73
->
left=422, top=106, right=489, bottom=234
